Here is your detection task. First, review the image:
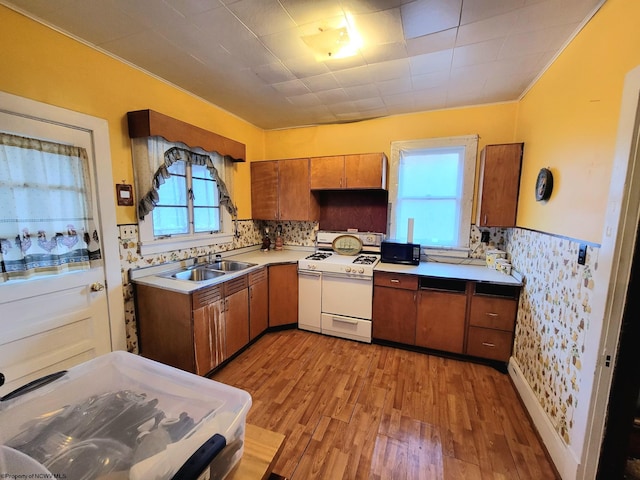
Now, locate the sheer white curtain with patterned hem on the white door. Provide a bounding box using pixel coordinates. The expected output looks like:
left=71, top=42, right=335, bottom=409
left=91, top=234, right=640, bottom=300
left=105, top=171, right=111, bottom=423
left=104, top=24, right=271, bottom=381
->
left=0, top=133, right=101, bottom=282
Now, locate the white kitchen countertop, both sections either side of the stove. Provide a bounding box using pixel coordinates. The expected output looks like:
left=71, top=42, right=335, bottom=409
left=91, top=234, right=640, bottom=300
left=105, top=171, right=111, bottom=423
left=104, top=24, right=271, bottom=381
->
left=131, top=247, right=522, bottom=294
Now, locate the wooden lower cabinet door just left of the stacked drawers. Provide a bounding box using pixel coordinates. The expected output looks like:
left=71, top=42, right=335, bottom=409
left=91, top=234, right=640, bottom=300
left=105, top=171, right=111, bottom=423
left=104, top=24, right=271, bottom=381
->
left=416, top=290, right=467, bottom=353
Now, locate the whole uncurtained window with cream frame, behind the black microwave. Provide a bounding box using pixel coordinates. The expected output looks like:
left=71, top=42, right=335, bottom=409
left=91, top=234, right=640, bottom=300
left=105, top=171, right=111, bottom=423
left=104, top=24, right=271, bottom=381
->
left=389, top=135, right=478, bottom=257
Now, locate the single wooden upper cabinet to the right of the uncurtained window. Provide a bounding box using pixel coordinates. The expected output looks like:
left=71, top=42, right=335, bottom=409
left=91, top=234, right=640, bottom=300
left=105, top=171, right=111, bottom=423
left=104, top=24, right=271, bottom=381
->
left=476, top=143, right=524, bottom=227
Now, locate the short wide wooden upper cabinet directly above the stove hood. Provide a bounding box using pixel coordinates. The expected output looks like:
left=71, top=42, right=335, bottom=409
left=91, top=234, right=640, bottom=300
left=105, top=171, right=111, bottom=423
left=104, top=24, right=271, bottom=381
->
left=310, top=153, right=387, bottom=190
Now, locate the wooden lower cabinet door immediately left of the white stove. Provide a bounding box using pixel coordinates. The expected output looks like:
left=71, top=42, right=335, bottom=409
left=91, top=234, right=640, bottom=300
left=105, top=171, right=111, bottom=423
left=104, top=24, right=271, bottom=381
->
left=269, top=263, right=298, bottom=327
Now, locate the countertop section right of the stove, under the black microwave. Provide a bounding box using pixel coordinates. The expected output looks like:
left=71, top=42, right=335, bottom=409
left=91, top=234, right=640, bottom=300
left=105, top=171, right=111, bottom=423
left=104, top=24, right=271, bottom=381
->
left=374, top=262, right=522, bottom=285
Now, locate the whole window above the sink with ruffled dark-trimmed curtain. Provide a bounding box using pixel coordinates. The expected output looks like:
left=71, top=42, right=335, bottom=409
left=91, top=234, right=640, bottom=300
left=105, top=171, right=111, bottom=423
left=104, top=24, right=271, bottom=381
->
left=132, top=137, right=235, bottom=254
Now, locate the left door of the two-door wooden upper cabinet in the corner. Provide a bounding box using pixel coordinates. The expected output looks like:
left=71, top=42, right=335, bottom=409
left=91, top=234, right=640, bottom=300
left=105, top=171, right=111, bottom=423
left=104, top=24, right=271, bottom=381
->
left=251, top=161, right=279, bottom=220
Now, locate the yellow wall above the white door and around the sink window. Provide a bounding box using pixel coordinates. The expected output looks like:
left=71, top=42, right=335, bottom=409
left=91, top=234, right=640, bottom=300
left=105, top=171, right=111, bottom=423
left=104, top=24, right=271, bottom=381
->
left=0, top=5, right=264, bottom=224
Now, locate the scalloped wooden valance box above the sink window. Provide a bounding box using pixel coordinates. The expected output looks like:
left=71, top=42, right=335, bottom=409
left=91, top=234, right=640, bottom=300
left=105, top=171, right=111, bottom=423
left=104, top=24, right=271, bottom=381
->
left=127, top=110, right=246, bottom=162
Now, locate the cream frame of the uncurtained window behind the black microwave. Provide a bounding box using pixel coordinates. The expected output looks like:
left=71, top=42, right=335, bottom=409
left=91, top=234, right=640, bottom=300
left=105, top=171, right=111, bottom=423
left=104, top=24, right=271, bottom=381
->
left=388, top=135, right=479, bottom=257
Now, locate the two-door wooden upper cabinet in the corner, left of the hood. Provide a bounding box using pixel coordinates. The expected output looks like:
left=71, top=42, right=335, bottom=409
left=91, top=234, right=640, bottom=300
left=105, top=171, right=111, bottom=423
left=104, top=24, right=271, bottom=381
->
left=251, top=158, right=320, bottom=221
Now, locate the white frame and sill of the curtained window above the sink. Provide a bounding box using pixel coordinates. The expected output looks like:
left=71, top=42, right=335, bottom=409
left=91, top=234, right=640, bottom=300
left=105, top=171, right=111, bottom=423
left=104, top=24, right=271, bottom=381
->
left=138, top=141, right=234, bottom=255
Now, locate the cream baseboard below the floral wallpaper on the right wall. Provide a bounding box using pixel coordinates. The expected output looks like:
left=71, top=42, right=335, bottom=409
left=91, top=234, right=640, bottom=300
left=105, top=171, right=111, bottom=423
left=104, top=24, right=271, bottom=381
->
left=508, top=357, right=580, bottom=480
